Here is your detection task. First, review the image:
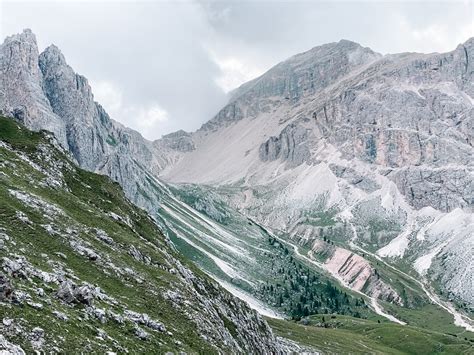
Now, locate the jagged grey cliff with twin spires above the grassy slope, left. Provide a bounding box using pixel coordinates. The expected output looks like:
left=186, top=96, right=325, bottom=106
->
left=0, top=30, right=183, bottom=220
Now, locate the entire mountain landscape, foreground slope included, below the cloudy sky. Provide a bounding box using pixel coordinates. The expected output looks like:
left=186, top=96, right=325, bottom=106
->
left=0, top=30, right=474, bottom=354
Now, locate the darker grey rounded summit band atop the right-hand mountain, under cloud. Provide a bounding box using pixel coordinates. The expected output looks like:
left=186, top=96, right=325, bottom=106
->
left=202, top=39, right=382, bottom=131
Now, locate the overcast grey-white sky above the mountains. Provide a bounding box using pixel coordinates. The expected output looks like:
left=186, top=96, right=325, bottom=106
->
left=0, top=0, right=474, bottom=139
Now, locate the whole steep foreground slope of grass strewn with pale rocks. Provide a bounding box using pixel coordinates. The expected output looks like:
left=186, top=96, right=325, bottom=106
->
left=0, top=117, right=283, bottom=353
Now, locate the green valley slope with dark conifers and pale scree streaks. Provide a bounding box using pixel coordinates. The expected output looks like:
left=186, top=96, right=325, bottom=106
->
left=160, top=185, right=375, bottom=319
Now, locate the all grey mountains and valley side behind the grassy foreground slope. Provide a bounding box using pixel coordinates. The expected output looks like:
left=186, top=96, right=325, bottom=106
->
left=0, top=30, right=474, bottom=342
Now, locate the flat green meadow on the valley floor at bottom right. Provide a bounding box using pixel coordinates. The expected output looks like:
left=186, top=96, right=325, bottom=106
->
left=268, top=315, right=474, bottom=354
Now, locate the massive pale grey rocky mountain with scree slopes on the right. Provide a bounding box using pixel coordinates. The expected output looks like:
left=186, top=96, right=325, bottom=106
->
left=160, top=39, right=474, bottom=308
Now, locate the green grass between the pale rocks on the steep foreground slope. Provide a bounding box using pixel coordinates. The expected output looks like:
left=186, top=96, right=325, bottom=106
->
left=0, top=118, right=266, bottom=353
